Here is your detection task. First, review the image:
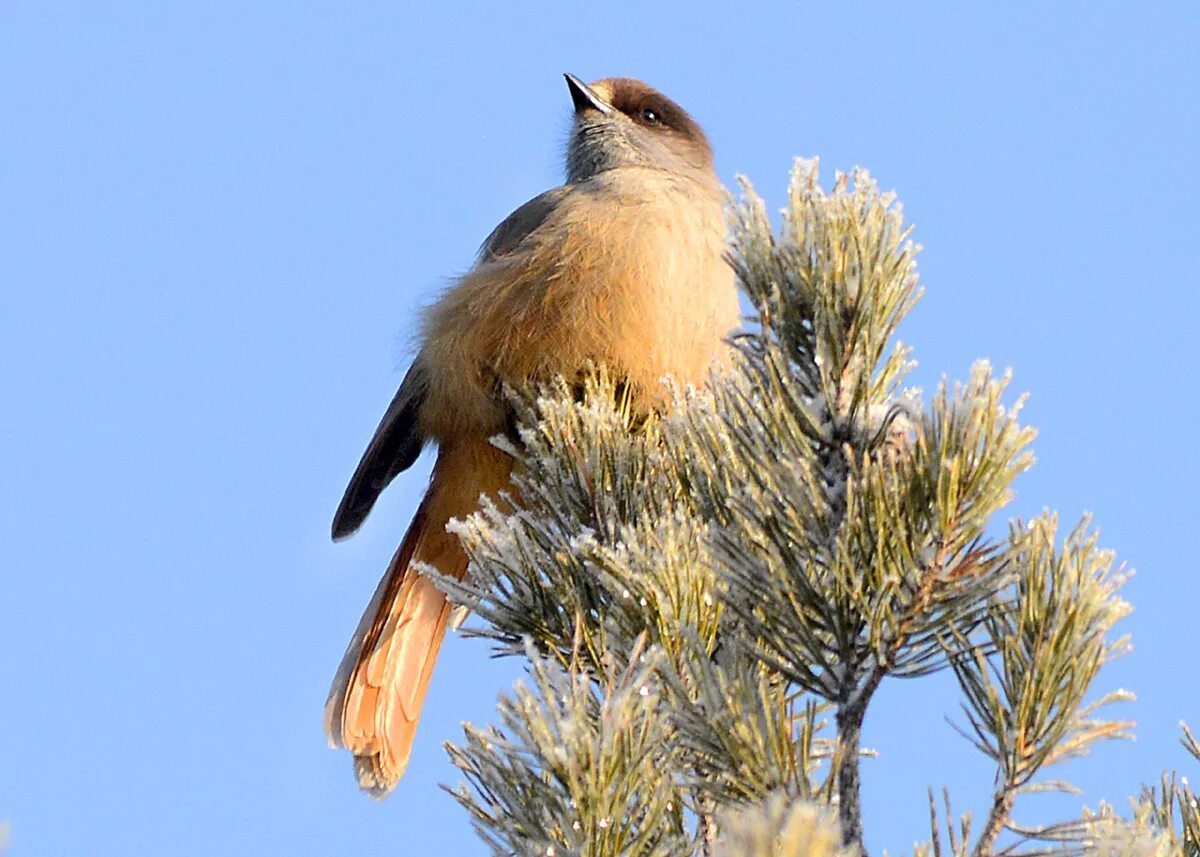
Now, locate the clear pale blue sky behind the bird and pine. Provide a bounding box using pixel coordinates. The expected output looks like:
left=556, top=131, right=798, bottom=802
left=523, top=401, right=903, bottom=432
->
left=0, top=1, right=1200, bottom=857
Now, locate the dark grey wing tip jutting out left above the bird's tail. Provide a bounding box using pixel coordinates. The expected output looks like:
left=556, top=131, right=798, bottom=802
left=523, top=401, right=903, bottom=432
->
left=334, top=358, right=430, bottom=540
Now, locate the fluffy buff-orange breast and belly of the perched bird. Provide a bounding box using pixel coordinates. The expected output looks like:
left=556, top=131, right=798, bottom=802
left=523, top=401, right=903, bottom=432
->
left=422, top=169, right=738, bottom=437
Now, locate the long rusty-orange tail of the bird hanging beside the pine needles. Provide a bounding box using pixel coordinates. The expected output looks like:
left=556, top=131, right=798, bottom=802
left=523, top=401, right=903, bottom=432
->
left=325, top=441, right=511, bottom=797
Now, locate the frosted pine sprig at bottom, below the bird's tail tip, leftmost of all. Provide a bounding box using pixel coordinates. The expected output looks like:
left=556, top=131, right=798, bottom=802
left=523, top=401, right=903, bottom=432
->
left=448, top=647, right=688, bottom=857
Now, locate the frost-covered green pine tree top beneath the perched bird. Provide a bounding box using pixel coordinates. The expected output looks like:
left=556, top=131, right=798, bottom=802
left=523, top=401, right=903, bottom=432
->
left=430, top=161, right=1200, bottom=857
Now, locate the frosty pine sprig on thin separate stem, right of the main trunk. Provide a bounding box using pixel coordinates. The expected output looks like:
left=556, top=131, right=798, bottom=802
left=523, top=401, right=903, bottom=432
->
left=952, top=516, right=1133, bottom=857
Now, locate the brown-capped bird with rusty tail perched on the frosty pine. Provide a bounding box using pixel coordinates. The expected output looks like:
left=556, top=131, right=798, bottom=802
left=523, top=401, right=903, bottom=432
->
left=325, top=74, right=739, bottom=797
